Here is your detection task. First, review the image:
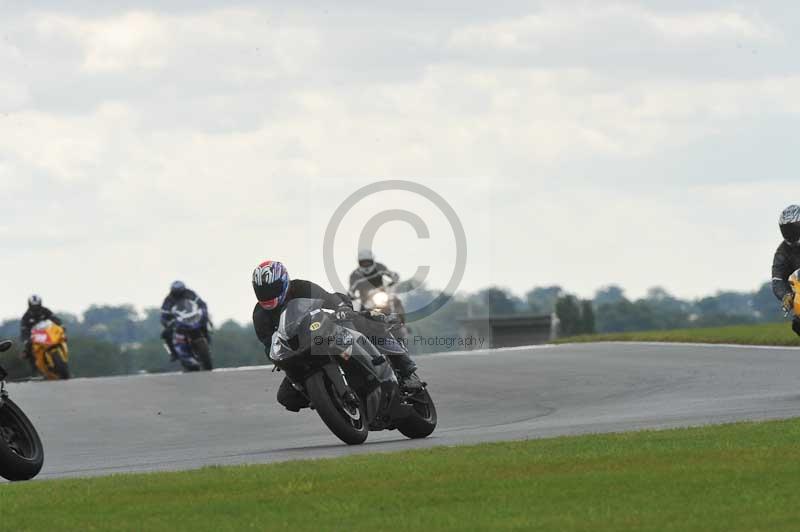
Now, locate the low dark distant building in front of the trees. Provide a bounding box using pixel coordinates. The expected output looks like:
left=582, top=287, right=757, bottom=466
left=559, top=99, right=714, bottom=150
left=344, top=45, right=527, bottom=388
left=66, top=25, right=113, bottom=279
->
left=458, top=314, right=558, bottom=347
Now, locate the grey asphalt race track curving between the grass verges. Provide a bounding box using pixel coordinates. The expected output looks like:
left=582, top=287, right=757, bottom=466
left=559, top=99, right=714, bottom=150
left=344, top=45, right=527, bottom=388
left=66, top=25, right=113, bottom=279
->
left=9, top=344, right=800, bottom=478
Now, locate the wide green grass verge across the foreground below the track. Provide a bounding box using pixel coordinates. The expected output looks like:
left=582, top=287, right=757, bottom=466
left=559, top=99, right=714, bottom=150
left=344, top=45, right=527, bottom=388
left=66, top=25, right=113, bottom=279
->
left=0, top=420, right=800, bottom=532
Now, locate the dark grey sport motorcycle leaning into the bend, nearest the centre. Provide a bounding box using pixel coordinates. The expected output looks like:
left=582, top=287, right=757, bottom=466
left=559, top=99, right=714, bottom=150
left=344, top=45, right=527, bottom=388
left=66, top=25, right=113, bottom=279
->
left=270, top=298, right=437, bottom=445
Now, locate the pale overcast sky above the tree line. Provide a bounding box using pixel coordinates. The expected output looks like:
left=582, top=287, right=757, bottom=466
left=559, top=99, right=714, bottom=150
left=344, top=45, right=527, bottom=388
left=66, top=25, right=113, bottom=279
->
left=0, top=0, right=800, bottom=321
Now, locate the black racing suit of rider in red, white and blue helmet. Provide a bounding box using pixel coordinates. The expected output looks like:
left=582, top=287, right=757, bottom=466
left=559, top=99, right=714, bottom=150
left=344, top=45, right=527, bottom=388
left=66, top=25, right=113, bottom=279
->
left=253, top=279, right=417, bottom=412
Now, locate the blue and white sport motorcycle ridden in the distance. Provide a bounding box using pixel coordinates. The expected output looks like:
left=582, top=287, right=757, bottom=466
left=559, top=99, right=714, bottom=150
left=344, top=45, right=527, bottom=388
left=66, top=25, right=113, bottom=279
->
left=165, top=299, right=213, bottom=371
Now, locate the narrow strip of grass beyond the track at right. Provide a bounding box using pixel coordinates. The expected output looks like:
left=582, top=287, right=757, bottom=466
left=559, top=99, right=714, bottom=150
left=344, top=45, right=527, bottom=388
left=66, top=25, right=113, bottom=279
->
left=556, top=323, right=800, bottom=346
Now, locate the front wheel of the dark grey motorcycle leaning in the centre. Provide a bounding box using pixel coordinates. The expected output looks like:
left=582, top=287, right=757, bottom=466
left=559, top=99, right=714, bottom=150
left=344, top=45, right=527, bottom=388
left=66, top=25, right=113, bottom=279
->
left=306, top=371, right=369, bottom=445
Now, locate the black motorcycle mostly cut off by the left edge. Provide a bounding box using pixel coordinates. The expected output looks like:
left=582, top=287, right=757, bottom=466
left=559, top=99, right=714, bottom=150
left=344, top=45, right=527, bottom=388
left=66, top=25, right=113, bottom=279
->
left=0, top=340, right=44, bottom=481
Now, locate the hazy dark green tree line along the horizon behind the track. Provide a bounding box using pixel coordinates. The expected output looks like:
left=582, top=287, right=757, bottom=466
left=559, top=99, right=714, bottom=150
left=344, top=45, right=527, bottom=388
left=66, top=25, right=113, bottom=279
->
left=0, top=283, right=782, bottom=378
